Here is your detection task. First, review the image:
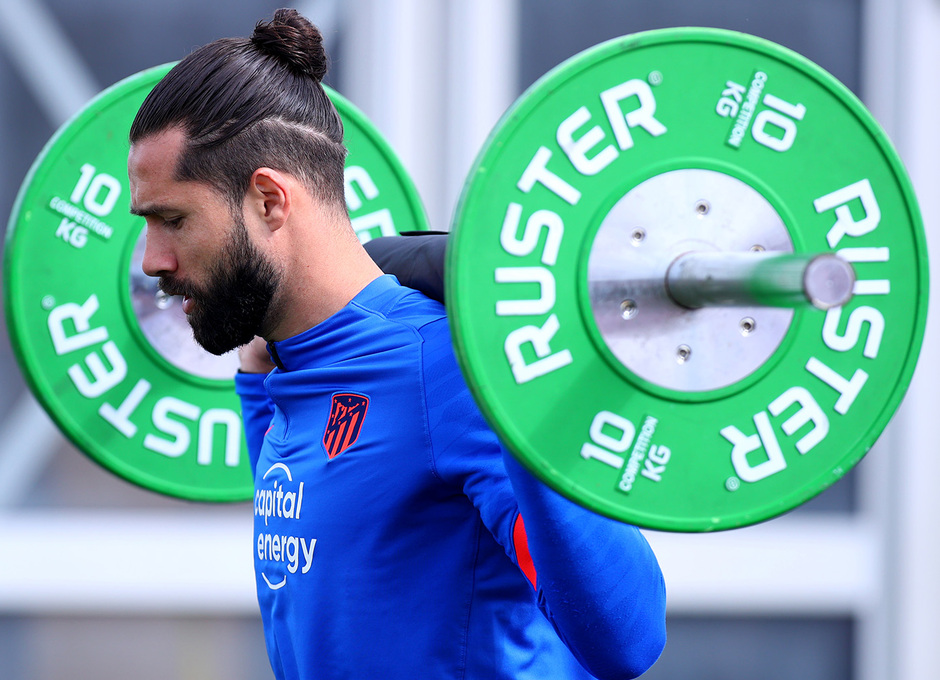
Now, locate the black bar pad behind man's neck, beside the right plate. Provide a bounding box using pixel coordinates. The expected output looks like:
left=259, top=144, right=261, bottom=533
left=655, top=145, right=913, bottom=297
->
left=365, top=231, right=447, bottom=303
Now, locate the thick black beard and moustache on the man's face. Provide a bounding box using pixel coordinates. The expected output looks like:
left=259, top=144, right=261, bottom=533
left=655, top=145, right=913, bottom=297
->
left=160, top=222, right=280, bottom=355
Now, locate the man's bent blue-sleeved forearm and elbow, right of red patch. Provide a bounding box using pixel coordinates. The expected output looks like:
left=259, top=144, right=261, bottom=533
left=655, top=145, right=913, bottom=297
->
left=504, top=453, right=666, bottom=678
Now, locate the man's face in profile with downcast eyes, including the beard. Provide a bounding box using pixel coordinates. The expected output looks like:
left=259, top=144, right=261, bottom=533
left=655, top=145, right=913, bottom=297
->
left=128, top=130, right=279, bottom=354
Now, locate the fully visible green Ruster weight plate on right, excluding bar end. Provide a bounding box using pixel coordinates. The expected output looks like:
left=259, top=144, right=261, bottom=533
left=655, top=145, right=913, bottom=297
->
left=447, top=28, right=928, bottom=531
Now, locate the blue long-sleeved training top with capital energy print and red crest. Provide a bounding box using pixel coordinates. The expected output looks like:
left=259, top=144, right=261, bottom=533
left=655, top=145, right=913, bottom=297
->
left=236, top=276, right=665, bottom=680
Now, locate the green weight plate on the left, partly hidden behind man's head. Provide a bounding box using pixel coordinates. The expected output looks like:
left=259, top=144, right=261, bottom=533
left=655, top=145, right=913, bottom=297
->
left=4, top=64, right=428, bottom=501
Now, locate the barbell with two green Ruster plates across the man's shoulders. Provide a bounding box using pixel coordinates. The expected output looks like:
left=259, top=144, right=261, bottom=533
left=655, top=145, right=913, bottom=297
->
left=5, top=28, right=928, bottom=531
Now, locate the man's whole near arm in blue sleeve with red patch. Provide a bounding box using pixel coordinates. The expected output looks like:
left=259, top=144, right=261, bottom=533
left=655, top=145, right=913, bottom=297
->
left=423, top=318, right=666, bottom=680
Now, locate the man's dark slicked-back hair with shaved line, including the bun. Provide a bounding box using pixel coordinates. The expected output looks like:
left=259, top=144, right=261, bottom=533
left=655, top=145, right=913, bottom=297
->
left=130, top=9, right=346, bottom=216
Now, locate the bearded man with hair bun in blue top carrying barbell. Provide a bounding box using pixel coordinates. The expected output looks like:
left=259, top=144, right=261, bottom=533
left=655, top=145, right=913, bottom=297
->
left=128, top=10, right=665, bottom=680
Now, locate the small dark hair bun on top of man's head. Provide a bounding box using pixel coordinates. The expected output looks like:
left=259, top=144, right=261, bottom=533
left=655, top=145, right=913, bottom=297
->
left=251, top=9, right=326, bottom=82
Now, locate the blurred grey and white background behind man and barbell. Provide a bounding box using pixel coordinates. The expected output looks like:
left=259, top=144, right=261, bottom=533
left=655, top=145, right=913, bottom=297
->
left=0, top=0, right=940, bottom=680
